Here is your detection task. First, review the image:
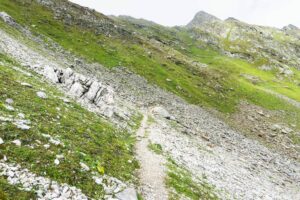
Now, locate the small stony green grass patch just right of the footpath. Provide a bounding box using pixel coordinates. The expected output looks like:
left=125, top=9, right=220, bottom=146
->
left=166, top=159, right=219, bottom=200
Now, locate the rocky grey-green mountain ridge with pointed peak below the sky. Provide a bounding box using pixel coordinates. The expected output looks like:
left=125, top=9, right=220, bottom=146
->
left=186, top=12, right=300, bottom=73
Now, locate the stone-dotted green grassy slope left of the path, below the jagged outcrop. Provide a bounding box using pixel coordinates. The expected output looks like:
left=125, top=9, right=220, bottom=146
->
left=0, top=56, right=138, bottom=198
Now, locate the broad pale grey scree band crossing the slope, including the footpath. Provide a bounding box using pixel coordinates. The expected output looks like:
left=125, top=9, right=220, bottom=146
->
left=0, top=12, right=300, bottom=200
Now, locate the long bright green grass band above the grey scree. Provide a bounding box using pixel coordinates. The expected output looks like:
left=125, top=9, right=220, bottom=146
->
left=0, top=0, right=300, bottom=117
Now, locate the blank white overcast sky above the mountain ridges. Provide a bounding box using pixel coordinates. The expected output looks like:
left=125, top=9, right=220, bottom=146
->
left=71, top=0, right=300, bottom=28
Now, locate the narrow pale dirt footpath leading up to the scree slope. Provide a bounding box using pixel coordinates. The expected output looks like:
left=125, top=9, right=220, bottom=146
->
left=136, top=114, right=168, bottom=200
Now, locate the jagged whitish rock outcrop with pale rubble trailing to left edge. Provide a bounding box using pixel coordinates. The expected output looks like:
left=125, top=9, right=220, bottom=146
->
left=0, top=26, right=114, bottom=117
